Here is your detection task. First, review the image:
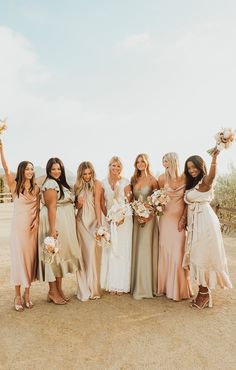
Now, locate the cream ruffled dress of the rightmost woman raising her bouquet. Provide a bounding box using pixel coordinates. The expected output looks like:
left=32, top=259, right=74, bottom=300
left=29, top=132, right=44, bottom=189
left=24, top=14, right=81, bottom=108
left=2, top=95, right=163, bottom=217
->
left=183, top=180, right=232, bottom=289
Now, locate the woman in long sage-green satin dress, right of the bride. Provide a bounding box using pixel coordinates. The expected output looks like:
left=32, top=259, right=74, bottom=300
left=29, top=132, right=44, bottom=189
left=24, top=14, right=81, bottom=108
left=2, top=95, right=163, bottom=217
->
left=130, top=154, right=159, bottom=299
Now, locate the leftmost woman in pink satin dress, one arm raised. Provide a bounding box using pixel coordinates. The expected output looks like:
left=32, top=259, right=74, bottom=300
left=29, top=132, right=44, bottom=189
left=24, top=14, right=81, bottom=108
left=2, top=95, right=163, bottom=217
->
left=0, top=141, right=39, bottom=311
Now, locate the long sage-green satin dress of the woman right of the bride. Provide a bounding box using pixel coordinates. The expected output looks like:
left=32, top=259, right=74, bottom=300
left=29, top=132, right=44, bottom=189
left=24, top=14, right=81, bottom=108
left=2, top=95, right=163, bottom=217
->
left=131, top=186, right=158, bottom=299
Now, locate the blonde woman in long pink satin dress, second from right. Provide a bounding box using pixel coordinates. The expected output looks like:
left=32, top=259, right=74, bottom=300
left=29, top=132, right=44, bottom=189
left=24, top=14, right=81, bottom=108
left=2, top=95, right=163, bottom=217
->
left=158, top=153, right=190, bottom=301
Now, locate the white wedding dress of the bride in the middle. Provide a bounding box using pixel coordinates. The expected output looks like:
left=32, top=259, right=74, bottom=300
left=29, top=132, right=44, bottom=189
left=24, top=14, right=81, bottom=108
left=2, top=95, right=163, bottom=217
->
left=101, top=178, right=133, bottom=293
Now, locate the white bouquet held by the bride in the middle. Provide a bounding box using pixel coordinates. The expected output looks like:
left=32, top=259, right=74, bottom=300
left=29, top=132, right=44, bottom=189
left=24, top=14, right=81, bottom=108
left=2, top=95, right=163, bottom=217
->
left=106, top=199, right=133, bottom=226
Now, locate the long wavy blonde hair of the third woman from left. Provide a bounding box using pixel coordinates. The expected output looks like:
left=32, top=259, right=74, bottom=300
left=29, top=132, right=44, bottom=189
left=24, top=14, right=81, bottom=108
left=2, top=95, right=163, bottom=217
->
left=75, top=162, right=96, bottom=196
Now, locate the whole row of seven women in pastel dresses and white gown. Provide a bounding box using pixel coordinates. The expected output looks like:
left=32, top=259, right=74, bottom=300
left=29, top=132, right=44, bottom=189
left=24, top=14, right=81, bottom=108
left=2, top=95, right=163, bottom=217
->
left=0, top=143, right=232, bottom=311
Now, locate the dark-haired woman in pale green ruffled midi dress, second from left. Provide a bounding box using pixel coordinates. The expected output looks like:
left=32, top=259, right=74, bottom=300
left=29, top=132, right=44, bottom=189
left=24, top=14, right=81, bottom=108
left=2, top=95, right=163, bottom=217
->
left=38, top=158, right=89, bottom=305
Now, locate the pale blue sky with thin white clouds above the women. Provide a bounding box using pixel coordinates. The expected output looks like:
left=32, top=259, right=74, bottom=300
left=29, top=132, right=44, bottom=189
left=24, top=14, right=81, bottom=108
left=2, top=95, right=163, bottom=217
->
left=0, top=0, right=236, bottom=177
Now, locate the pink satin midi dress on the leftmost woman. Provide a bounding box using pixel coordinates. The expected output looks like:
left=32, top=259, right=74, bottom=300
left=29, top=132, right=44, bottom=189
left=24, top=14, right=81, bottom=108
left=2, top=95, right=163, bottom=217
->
left=10, top=193, right=39, bottom=288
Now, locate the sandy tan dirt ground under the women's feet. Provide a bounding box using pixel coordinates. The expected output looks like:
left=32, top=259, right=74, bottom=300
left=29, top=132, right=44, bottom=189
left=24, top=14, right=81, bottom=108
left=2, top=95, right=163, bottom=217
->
left=0, top=204, right=236, bottom=370
